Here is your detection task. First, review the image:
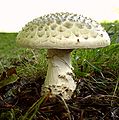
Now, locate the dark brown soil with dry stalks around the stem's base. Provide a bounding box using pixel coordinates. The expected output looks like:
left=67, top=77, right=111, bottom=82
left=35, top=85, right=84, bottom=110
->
left=0, top=68, right=119, bottom=120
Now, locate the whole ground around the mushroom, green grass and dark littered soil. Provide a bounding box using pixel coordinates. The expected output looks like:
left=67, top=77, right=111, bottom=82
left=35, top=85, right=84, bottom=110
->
left=0, top=21, right=119, bottom=120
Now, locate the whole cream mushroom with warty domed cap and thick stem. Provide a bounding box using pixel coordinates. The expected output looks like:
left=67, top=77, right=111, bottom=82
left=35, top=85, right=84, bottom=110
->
left=16, top=12, right=110, bottom=100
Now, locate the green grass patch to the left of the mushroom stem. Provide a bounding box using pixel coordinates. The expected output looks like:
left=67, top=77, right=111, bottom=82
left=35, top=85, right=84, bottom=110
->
left=0, top=33, right=47, bottom=75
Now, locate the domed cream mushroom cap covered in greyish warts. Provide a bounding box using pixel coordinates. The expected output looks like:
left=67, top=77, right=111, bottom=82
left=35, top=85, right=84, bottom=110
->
left=16, top=12, right=110, bottom=49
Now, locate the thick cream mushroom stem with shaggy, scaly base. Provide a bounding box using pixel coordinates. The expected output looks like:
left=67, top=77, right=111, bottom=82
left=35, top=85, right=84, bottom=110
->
left=41, top=49, right=76, bottom=99
